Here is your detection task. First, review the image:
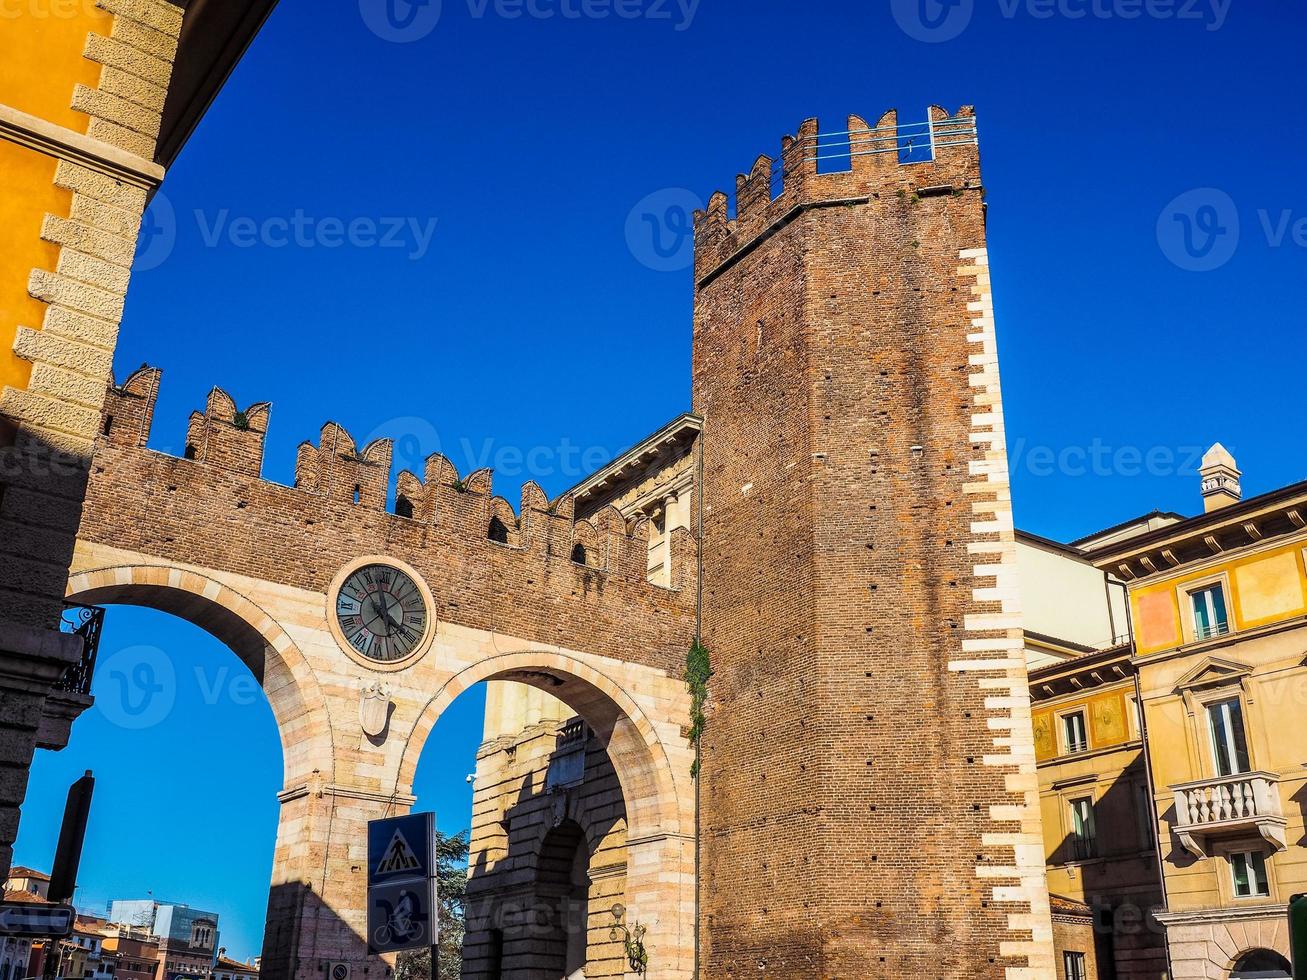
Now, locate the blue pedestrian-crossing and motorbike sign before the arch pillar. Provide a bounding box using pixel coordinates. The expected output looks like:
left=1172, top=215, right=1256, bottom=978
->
left=367, top=813, right=439, bottom=953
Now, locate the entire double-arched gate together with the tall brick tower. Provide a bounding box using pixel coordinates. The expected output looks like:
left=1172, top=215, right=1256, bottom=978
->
left=61, top=107, right=1055, bottom=980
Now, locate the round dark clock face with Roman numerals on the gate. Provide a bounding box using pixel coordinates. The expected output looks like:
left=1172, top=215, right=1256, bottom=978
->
left=336, top=564, right=427, bottom=664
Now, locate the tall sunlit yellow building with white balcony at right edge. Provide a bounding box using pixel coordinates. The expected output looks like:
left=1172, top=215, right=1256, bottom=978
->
left=1093, top=446, right=1307, bottom=980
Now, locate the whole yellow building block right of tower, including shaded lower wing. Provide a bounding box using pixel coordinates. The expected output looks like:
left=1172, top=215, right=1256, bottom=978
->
left=1031, top=446, right=1307, bottom=980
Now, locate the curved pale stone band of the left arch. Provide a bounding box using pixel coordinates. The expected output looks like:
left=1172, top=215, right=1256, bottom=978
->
left=68, top=564, right=335, bottom=787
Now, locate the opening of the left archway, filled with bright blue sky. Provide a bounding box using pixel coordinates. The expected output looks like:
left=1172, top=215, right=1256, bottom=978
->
left=16, top=606, right=284, bottom=976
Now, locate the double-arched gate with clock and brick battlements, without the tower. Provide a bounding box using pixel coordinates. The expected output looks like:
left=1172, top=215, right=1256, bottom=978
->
left=68, top=368, right=697, bottom=980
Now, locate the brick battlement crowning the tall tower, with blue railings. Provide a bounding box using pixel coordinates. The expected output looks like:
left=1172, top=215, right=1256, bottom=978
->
left=694, top=106, right=980, bottom=282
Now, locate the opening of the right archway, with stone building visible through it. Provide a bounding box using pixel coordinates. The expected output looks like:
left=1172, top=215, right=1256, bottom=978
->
left=402, top=664, right=650, bottom=980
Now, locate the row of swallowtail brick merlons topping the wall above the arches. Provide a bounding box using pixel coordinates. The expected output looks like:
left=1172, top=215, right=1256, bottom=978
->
left=97, top=366, right=697, bottom=591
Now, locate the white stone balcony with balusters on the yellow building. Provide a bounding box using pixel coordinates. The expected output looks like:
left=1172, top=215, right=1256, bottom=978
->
left=1170, top=772, right=1287, bottom=857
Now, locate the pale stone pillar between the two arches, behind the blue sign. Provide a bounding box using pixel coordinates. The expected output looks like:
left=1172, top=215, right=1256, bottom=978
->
left=263, top=772, right=414, bottom=980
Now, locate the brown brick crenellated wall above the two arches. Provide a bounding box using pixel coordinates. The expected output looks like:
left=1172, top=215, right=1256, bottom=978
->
left=90, top=368, right=697, bottom=655
